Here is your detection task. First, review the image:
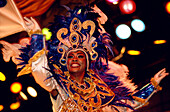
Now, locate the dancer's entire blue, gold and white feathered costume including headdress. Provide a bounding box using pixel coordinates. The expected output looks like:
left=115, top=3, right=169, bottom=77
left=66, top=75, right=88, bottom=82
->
left=0, top=2, right=165, bottom=112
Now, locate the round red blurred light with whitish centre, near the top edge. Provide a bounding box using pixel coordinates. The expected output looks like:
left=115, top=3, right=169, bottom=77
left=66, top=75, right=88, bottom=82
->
left=119, top=0, right=136, bottom=14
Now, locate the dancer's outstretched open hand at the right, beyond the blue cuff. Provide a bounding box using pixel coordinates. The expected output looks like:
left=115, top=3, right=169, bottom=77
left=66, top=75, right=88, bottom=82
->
left=154, top=68, right=169, bottom=84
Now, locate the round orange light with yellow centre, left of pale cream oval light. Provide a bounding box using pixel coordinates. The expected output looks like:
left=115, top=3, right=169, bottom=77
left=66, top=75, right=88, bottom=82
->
left=10, top=82, right=22, bottom=93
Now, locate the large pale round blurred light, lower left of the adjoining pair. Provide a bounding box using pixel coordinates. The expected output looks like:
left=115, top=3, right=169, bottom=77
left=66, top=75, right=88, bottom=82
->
left=116, top=24, right=131, bottom=39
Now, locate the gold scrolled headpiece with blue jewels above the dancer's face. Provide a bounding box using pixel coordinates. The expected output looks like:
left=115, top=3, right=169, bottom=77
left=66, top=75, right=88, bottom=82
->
left=56, top=17, right=98, bottom=65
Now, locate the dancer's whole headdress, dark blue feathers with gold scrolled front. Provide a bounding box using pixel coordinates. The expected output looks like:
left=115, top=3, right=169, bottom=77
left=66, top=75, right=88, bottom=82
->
left=47, top=7, right=111, bottom=72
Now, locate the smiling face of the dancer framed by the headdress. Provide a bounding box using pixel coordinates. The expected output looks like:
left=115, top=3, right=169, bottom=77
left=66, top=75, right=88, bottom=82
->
left=67, top=50, right=86, bottom=73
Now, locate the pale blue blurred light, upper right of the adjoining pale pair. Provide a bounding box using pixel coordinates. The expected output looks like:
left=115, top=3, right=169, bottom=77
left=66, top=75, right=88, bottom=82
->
left=131, top=19, right=145, bottom=32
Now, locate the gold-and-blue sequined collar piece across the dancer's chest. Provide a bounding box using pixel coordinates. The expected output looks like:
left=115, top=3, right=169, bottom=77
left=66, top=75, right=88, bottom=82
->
left=59, top=70, right=115, bottom=112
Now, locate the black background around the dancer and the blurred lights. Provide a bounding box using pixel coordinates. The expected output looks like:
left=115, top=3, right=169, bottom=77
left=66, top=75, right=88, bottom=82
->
left=0, top=0, right=170, bottom=112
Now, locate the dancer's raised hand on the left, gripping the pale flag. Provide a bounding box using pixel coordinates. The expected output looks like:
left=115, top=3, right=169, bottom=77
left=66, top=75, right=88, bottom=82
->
left=24, top=17, right=41, bottom=33
